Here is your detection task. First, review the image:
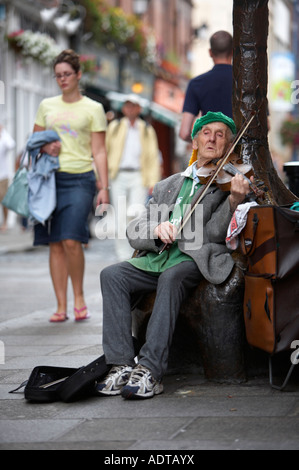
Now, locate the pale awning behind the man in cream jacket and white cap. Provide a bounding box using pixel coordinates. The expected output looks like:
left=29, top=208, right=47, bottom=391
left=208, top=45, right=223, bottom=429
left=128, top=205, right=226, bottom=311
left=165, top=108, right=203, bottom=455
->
left=106, top=91, right=180, bottom=127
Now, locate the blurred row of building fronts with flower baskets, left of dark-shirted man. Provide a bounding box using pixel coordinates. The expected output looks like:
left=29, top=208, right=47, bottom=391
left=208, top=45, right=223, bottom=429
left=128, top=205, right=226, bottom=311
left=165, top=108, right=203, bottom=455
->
left=0, top=0, right=192, bottom=180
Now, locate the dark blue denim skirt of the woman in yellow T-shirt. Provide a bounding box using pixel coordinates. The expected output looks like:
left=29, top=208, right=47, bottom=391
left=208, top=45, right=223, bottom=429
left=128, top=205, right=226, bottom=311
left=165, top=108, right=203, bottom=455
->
left=33, top=171, right=96, bottom=246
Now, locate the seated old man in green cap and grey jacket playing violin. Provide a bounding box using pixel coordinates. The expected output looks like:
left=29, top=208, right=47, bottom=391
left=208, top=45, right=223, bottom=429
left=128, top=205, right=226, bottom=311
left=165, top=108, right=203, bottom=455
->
left=97, top=112, right=250, bottom=399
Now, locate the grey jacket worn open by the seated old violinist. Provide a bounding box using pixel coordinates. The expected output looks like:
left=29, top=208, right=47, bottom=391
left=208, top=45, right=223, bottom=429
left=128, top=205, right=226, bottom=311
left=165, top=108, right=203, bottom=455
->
left=127, top=173, right=234, bottom=284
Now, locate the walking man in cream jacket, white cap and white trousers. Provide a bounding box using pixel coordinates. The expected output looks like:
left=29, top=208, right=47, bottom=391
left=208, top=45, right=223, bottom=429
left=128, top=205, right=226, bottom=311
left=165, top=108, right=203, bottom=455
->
left=106, top=94, right=161, bottom=261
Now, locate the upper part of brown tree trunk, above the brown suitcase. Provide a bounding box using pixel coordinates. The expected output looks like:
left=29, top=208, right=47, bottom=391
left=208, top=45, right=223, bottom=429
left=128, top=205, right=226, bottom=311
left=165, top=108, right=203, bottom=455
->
left=233, top=0, right=297, bottom=205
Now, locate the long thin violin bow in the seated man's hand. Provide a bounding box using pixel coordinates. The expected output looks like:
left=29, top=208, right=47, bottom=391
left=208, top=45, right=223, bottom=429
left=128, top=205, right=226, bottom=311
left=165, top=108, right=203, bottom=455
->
left=159, top=111, right=256, bottom=255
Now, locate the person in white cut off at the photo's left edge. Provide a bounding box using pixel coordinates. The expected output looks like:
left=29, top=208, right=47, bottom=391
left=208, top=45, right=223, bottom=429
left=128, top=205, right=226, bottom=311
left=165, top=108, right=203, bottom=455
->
left=0, top=124, right=16, bottom=232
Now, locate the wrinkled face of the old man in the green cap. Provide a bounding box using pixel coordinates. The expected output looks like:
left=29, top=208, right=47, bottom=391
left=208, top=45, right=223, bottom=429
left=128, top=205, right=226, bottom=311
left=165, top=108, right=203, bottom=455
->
left=193, top=122, right=230, bottom=165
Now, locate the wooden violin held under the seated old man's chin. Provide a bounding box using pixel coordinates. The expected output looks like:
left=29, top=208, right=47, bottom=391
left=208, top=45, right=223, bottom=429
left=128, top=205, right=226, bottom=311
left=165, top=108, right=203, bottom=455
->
left=197, top=153, right=265, bottom=199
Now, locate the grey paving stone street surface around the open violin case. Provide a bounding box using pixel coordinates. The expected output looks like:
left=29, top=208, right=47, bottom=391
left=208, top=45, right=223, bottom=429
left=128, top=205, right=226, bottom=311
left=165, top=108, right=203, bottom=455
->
left=0, top=226, right=299, bottom=454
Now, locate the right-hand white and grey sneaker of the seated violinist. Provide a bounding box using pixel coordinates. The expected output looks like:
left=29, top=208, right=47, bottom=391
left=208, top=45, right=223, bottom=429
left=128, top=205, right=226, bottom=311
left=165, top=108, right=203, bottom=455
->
left=121, top=364, right=163, bottom=398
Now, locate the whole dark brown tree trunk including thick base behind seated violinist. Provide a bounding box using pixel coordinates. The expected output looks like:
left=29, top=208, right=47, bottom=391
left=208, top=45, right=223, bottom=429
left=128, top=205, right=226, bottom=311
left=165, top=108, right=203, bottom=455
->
left=133, top=0, right=296, bottom=382
